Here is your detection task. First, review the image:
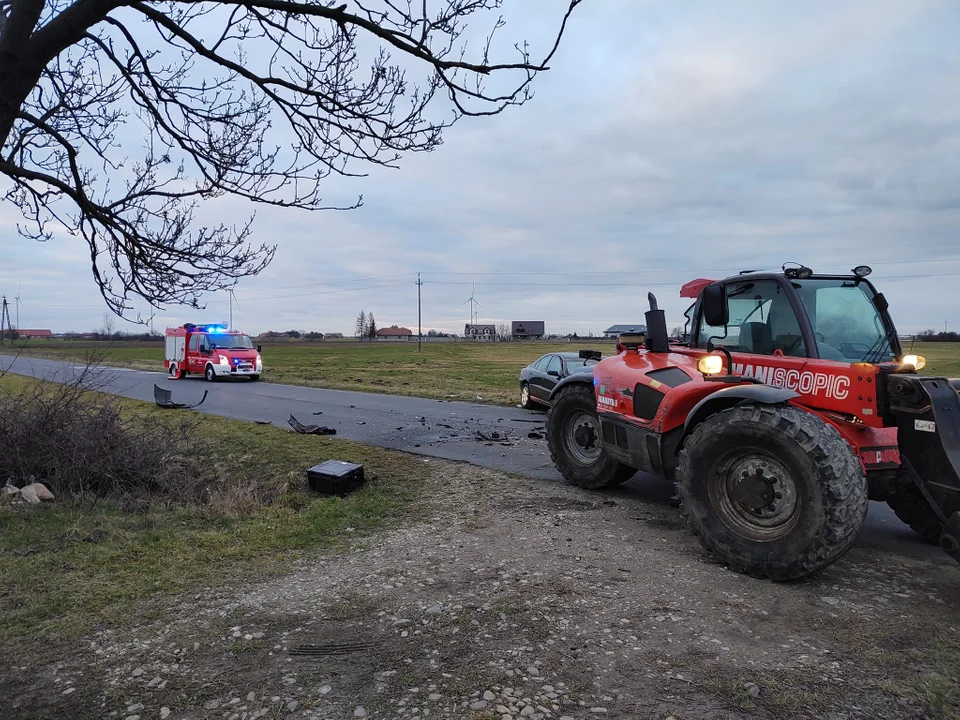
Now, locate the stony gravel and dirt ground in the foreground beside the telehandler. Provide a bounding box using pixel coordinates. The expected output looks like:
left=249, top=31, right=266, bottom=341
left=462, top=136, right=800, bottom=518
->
left=0, top=459, right=960, bottom=720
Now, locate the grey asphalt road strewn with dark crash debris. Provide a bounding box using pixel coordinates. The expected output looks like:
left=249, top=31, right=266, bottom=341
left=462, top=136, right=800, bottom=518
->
left=0, top=355, right=947, bottom=560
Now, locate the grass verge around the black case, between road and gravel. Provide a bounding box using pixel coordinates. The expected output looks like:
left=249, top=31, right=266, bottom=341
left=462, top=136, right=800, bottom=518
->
left=0, top=375, right=436, bottom=644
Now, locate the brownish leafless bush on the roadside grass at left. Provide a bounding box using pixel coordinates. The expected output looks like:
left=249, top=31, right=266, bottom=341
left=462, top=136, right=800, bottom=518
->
left=0, top=364, right=210, bottom=507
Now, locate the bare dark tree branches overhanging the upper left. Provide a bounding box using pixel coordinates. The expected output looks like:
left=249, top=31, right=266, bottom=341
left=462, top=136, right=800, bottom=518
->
left=0, top=0, right=582, bottom=316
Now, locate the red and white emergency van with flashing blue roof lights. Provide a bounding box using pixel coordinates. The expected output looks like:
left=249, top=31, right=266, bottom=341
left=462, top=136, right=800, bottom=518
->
left=163, top=323, right=263, bottom=382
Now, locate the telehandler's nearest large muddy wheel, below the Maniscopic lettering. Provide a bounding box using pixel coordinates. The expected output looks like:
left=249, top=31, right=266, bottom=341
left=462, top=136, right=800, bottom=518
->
left=677, top=405, right=868, bottom=581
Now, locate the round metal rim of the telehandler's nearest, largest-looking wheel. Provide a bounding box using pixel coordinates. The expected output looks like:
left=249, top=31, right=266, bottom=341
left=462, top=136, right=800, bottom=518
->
left=708, top=453, right=800, bottom=542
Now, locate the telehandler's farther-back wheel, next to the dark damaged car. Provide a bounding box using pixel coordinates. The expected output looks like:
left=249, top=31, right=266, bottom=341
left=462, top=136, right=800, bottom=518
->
left=547, top=383, right=637, bottom=490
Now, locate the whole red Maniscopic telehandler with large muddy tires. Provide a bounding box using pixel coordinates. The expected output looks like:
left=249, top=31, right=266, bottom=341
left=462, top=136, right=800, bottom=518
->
left=547, top=265, right=960, bottom=581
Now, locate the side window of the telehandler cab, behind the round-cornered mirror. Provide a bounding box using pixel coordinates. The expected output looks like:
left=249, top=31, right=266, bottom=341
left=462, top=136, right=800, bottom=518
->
left=696, top=280, right=807, bottom=357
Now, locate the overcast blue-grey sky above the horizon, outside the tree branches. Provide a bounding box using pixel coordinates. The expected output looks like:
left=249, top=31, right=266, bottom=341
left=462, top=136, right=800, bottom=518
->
left=0, top=0, right=960, bottom=333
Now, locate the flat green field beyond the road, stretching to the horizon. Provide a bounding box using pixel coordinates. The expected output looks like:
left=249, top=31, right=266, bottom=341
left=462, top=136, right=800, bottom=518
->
left=3, top=340, right=960, bottom=405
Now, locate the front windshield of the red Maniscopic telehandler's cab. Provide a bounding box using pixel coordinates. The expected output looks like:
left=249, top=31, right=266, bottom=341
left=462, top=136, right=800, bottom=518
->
left=794, top=278, right=896, bottom=363
